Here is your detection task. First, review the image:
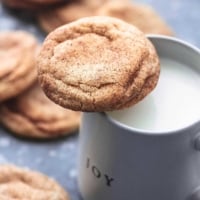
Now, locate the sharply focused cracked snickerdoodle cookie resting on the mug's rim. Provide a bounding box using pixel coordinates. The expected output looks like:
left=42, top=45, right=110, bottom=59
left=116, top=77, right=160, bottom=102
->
left=37, top=16, right=160, bottom=112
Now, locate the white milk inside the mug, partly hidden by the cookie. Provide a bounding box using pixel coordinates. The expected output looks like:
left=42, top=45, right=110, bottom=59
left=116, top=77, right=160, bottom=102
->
left=108, top=58, right=200, bottom=133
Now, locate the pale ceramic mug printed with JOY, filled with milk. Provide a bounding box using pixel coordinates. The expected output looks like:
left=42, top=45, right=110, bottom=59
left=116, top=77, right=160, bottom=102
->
left=78, top=35, right=200, bottom=200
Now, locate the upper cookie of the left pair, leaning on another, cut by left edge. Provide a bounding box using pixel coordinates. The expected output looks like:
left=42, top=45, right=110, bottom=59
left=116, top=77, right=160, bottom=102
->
left=0, top=31, right=39, bottom=102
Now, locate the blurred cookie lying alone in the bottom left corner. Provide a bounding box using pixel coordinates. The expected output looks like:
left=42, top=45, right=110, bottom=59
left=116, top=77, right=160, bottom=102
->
left=0, top=165, right=69, bottom=200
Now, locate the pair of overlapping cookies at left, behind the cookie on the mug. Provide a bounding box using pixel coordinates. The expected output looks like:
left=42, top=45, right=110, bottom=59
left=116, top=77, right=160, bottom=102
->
left=0, top=31, right=80, bottom=138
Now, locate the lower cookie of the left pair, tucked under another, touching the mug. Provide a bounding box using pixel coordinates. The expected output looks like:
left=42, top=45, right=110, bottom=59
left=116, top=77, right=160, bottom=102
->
left=0, top=84, right=80, bottom=139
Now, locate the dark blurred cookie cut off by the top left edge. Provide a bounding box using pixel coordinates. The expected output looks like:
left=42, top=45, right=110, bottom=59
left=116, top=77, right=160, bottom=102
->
left=2, top=0, right=65, bottom=10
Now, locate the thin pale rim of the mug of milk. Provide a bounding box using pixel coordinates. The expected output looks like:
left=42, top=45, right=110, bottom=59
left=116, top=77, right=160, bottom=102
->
left=105, top=34, right=200, bottom=136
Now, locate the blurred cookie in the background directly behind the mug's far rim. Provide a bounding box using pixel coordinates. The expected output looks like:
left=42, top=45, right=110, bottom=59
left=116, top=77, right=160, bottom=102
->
left=97, top=1, right=173, bottom=35
